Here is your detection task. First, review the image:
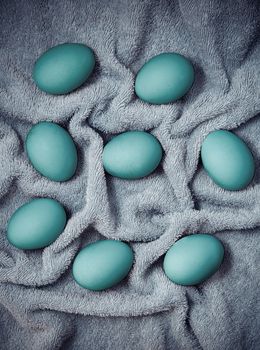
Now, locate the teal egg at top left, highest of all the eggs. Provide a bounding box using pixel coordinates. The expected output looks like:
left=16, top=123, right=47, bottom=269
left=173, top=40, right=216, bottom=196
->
left=33, top=43, right=95, bottom=95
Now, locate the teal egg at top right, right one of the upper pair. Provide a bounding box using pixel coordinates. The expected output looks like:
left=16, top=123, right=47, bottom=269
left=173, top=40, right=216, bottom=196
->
left=135, top=52, right=194, bottom=104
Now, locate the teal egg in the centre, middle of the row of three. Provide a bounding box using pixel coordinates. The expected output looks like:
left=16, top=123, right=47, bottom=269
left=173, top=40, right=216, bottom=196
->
left=103, top=131, right=162, bottom=179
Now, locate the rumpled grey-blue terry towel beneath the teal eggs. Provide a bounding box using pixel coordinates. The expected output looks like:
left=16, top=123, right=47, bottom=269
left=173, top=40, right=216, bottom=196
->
left=0, top=0, right=260, bottom=350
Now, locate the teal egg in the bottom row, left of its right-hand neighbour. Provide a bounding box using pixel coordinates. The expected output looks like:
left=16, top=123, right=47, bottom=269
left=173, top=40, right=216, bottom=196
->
left=72, top=240, right=134, bottom=290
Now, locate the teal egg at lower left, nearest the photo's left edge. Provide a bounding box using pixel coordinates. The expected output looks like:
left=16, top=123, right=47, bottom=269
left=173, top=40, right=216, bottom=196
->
left=7, top=198, right=67, bottom=249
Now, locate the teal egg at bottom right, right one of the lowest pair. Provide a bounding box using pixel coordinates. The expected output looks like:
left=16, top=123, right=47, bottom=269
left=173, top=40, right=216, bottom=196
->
left=163, top=234, right=224, bottom=286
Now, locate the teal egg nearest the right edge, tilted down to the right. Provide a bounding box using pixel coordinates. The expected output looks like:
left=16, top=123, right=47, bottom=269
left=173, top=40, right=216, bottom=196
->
left=201, top=130, right=255, bottom=191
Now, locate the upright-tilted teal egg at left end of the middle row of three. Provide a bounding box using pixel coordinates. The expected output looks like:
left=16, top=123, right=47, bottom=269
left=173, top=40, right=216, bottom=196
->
left=26, top=122, right=78, bottom=181
